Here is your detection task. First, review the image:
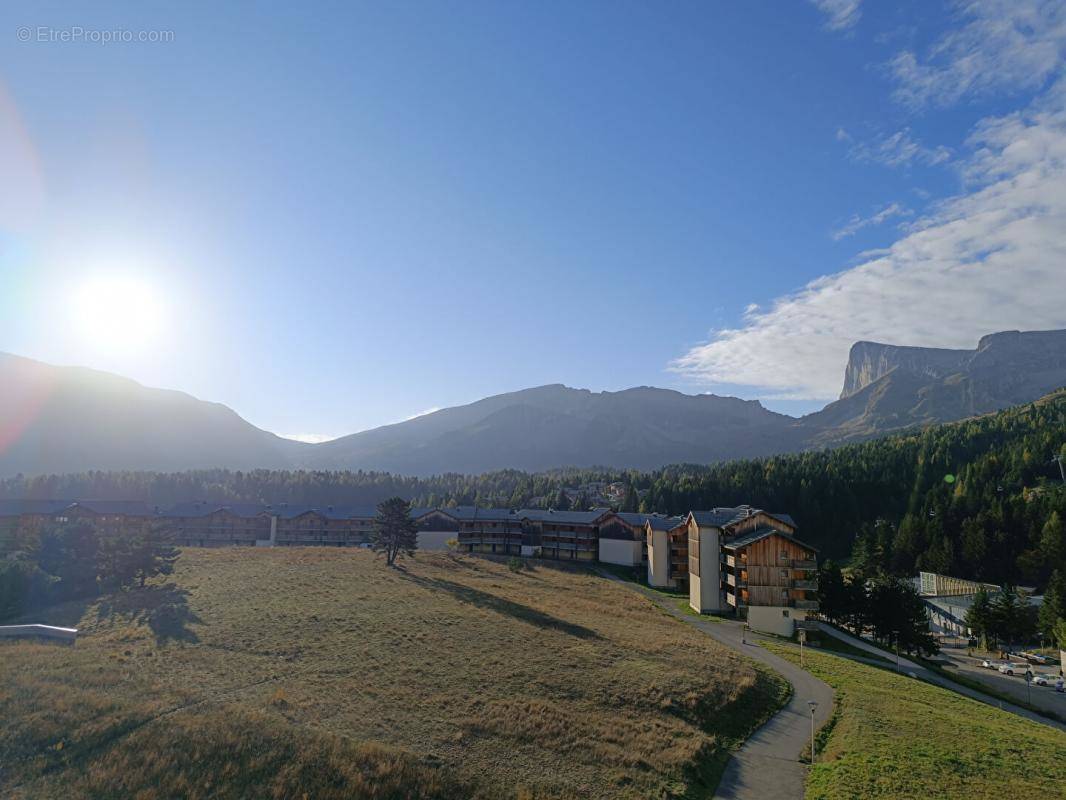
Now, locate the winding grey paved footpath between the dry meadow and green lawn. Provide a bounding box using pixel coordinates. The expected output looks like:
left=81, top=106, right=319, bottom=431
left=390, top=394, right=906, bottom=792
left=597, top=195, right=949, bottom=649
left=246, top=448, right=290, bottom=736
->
left=604, top=574, right=834, bottom=800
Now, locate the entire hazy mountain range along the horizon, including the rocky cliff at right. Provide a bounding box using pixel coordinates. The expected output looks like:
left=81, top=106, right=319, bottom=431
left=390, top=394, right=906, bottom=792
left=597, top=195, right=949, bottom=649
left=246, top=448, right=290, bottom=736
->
left=0, top=331, right=1066, bottom=477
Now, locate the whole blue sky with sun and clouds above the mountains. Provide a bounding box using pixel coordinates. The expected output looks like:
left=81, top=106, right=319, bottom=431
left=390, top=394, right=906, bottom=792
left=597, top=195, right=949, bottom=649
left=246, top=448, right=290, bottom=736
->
left=0, top=0, right=1066, bottom=435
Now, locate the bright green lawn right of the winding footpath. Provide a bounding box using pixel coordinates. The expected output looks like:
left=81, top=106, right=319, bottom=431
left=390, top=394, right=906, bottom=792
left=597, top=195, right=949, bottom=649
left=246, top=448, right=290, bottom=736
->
left=765, top=642, right=1066, bottom=800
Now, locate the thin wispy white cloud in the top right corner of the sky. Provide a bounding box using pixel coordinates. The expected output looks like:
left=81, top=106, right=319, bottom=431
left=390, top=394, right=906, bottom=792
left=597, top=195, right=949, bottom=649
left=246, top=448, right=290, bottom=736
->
left=888, top=0, right=1066, bottom=108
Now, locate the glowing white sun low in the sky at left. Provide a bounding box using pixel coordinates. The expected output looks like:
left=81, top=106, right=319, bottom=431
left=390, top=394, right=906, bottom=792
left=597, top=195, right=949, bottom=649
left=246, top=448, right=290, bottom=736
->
left=71, top=275, right=163, bottom=353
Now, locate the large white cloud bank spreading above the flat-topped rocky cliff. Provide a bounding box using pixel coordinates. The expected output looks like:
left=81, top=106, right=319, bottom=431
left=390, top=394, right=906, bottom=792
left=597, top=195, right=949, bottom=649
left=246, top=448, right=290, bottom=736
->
left=673, top=79, right=1066, bottom=399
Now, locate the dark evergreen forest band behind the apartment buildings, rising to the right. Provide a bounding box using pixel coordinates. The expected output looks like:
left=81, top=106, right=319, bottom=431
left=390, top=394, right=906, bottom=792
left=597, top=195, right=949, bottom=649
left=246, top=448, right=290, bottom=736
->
left=0, top=390, right=1066, bottom=586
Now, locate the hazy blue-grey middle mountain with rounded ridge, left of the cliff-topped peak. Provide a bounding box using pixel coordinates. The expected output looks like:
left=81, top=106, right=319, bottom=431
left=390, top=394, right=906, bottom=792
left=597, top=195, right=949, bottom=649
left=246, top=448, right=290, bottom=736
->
left=303, top=384, right=800, bottom=476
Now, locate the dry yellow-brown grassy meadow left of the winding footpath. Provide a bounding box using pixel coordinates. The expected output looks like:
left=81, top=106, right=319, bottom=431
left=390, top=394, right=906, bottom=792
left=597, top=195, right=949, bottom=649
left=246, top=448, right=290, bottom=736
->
left=0, top=548, right=787, bottom=800
